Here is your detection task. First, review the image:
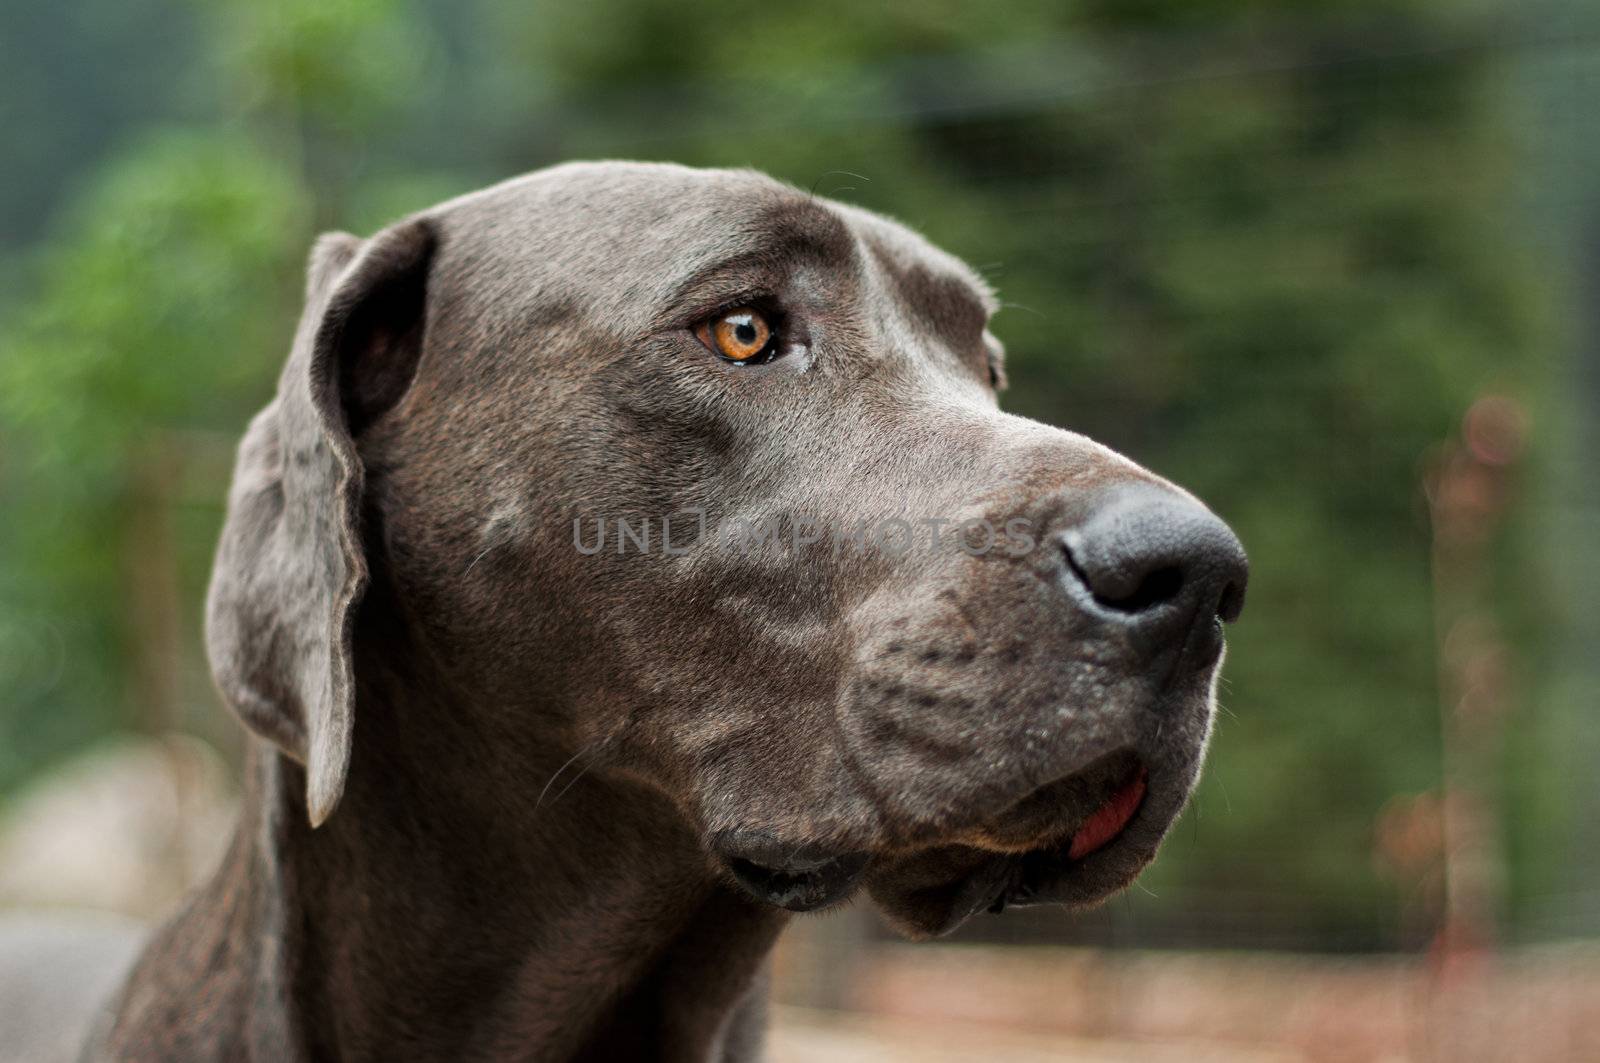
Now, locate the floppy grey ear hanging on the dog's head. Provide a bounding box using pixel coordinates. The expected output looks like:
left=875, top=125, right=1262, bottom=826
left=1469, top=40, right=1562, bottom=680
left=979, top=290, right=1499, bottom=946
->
left=206, top=219, right=435, bottom=826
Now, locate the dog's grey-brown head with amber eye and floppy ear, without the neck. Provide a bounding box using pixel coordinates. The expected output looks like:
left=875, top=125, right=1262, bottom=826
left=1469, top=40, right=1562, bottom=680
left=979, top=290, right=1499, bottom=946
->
left=211, top=163, right=1245, bottom=933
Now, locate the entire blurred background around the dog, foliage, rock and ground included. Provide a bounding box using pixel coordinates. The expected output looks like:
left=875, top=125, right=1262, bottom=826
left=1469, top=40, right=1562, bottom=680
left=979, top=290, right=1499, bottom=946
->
left=0, top=0, right=1600, bottom=1060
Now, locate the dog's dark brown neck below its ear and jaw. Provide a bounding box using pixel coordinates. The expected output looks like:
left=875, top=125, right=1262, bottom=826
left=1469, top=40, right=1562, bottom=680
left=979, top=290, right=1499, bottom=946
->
left=96, top=685, right=784, bottom=1060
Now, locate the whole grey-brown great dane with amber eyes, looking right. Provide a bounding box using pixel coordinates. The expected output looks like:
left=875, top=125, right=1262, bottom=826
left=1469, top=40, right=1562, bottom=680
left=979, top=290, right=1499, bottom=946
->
left=0, top=163, right=1246, bottom=1061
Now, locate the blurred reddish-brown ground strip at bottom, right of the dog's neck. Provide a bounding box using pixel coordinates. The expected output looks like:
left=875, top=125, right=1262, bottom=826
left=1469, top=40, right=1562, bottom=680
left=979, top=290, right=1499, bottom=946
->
left=773, top=945, right=1600, bottom=1063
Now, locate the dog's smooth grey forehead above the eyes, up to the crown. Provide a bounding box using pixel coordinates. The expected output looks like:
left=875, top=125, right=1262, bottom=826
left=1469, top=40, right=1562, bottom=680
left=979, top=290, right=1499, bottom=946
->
left=429, top=162, right=994, bottom=332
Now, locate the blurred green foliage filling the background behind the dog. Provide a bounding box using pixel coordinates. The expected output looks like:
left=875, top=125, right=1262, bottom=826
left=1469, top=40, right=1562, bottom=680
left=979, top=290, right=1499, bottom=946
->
left=0, top=0, right=1570, bottom=946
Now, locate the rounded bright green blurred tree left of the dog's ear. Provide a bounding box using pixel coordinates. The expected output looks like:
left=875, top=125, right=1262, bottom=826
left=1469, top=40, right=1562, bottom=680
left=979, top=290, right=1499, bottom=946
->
left=0, top=133, right=307, bottom=786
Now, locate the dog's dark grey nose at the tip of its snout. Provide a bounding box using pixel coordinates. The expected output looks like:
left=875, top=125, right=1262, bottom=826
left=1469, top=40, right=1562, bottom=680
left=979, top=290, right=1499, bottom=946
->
left=1061, top=483, right=1248, bottom=642
